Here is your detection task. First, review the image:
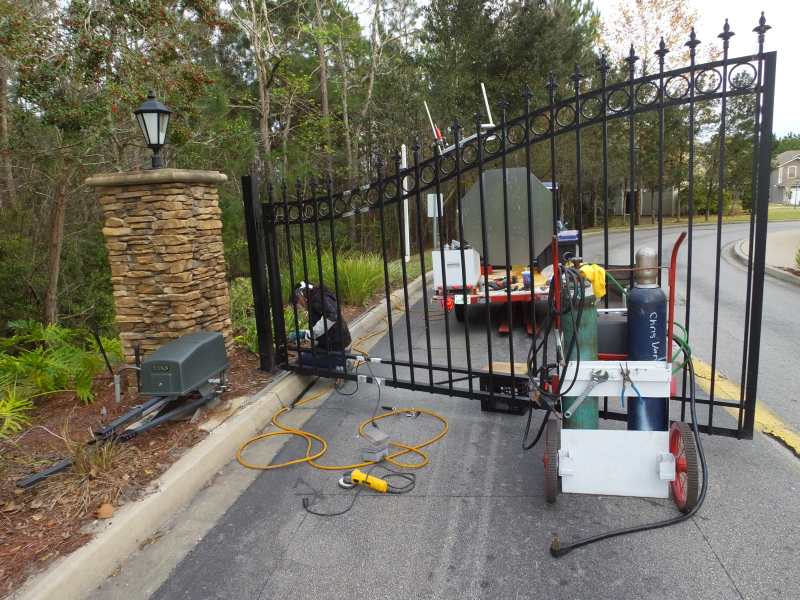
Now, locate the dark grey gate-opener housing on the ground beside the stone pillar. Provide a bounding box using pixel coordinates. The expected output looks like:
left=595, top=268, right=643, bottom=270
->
left=139, top=331, right=228, bottom=397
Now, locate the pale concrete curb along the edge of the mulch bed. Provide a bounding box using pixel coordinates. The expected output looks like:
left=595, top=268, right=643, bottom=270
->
left=11, top=273, right=431, bottom=600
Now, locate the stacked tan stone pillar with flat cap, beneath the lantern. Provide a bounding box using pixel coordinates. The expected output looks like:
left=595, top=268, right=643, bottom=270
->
left=86, top=169, right=233, bottom=363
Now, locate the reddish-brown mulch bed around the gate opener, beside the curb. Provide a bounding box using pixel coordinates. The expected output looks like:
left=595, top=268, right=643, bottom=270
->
left=0, top=347, right=270, bottom=598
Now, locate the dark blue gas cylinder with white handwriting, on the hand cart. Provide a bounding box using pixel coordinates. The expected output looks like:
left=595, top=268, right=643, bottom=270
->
left=627, top=248, right=669, bottom=431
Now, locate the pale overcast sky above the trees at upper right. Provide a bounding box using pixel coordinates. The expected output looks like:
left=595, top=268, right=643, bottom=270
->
left=594, top=0, right=800, bottom=136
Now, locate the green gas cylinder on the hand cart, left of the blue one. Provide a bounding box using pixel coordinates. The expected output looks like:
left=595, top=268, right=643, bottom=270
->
left=561, top=282, right=599, bottom=429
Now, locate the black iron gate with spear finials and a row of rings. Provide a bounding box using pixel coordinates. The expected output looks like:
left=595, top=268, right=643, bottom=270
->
left=243, top=15, right=776, bottom=438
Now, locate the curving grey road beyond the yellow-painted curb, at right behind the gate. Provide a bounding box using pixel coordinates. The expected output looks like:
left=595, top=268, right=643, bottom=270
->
left=584, top=218, right=800, bottom=431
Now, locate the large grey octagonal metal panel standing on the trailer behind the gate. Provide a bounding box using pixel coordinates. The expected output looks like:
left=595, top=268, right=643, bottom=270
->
left=460, top=167, right=553, bottom=264
